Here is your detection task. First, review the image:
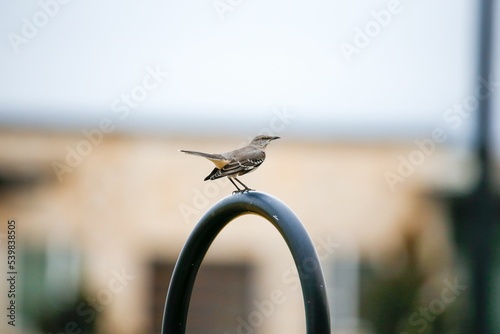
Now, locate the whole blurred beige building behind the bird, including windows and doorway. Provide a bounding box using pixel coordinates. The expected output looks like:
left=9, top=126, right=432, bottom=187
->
left=0, top=129, right=484, bottom=334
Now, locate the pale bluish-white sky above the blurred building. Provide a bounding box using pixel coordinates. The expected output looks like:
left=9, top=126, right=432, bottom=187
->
left=0, top=0, right=500, bottom=151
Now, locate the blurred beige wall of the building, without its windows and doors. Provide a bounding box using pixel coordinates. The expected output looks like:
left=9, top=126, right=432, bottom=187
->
left=0, top=130, right=473, bottom=334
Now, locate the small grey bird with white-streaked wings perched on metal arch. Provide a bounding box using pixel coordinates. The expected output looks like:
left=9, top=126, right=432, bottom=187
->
left=179, top=135, right=280, bottom=193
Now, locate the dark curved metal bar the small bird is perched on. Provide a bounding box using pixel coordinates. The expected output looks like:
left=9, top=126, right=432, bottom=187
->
left=162, top=191, right=330, bottom=334
